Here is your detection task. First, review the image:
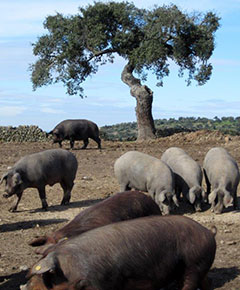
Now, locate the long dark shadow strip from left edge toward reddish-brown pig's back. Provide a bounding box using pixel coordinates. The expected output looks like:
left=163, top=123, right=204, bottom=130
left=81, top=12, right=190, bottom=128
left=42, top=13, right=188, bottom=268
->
left=0, top=219, right=68, bottom=233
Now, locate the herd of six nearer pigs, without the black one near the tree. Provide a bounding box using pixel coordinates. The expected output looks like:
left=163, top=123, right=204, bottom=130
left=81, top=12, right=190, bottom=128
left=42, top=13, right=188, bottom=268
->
left=0, top=140, right=239, bottom=290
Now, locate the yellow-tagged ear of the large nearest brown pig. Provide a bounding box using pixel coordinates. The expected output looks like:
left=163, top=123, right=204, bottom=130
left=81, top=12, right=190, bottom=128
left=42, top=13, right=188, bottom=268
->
left=27, top=252, right=55, bottom=277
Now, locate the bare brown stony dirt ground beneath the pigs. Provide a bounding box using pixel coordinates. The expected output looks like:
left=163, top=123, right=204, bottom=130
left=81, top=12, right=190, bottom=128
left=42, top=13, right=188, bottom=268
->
left=0, top=131, right=240, bottom=290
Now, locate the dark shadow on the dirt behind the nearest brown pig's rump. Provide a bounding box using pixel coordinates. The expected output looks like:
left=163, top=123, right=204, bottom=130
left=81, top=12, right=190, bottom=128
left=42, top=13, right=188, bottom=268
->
left=208, top=267, right=240, bottom=289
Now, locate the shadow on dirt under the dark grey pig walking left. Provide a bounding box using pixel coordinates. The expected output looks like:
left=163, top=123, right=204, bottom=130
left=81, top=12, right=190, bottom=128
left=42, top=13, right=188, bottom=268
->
left=31, top=198, right=104, bottom=213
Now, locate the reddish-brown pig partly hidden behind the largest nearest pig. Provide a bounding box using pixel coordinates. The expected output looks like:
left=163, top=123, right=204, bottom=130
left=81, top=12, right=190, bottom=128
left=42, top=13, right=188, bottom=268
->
left=29, top=191, right=161, bottom=249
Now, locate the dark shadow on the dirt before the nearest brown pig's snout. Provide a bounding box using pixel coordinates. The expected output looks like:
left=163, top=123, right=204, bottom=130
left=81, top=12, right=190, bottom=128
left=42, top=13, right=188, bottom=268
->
left=0, top=270, right=27, bottom=290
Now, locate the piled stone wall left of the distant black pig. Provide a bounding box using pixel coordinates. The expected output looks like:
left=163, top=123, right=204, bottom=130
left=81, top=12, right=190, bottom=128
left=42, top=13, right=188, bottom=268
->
left=0, top=125, right=50, bottom=142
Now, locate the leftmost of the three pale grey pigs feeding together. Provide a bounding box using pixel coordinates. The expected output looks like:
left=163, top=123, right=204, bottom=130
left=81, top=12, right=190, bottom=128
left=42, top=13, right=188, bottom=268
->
left=114, top=151, right=178, bottom=214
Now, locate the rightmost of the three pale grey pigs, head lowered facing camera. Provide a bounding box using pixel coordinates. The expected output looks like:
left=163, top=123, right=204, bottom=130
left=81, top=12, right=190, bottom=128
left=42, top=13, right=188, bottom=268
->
left=203, top=147, right=239, bottom=213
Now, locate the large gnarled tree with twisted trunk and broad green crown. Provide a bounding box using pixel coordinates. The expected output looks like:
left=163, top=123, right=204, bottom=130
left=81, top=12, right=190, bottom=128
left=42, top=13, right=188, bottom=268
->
left=30, top=2, right=219, bottom=139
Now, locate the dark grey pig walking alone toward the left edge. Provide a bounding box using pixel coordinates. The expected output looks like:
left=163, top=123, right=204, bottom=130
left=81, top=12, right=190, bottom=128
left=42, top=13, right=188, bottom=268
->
left=0, top=149, right=78, bottom=212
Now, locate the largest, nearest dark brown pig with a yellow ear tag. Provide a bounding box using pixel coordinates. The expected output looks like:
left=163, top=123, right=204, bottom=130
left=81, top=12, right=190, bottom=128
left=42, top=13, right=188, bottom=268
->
left=25, top=216, right=216, bottom=290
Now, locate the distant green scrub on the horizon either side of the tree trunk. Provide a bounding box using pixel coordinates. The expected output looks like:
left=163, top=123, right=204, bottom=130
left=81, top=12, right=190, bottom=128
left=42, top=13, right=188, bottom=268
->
left=100, top=117, right=240, bottom=141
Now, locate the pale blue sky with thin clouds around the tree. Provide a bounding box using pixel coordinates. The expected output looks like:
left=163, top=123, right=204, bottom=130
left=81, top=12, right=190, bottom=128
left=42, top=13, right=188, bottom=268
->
left=0, top=0, right=240, bottom=131
